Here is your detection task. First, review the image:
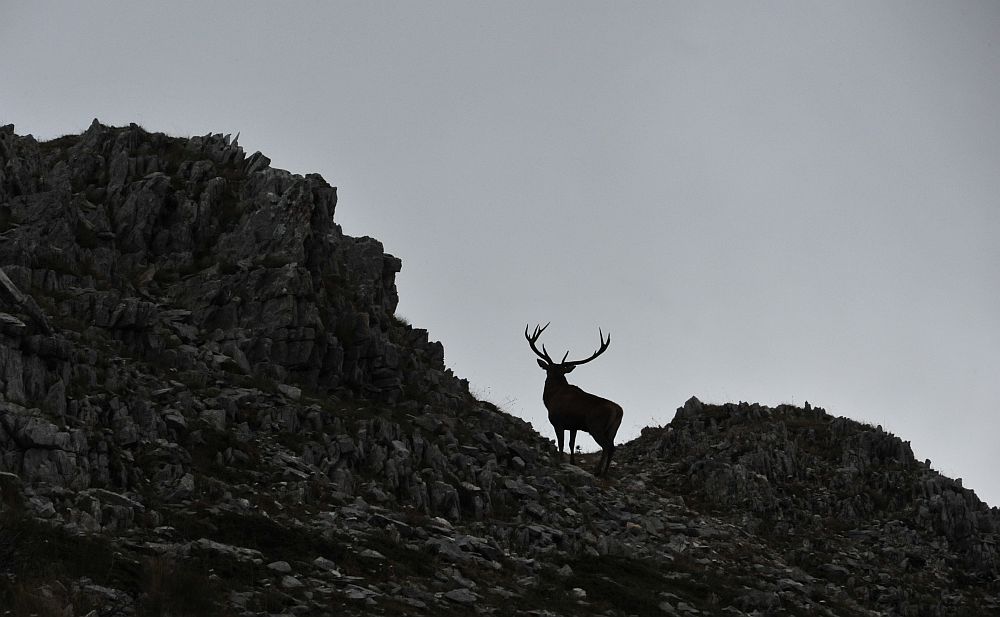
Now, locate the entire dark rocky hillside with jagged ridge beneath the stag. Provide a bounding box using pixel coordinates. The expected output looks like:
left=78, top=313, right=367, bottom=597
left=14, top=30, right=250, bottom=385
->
left=0, top=120, right=1000, bottom=617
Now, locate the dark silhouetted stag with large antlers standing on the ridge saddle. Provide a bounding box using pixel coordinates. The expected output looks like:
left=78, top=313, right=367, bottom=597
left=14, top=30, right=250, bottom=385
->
left=524, top=322, right=624, bottom=476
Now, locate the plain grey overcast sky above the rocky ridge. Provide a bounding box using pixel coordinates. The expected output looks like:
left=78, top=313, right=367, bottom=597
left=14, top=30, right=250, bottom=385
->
left=0, top=0, right=1000, bottom=506
